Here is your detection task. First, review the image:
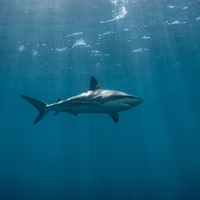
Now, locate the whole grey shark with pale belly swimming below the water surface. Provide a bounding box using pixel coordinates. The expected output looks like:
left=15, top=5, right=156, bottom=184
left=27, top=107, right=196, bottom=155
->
left=20, top=76, right=142, bottom=124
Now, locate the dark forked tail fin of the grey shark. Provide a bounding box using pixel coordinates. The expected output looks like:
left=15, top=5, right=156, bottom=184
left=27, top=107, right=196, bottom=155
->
left=20, top=95, right=48, bottom=124
